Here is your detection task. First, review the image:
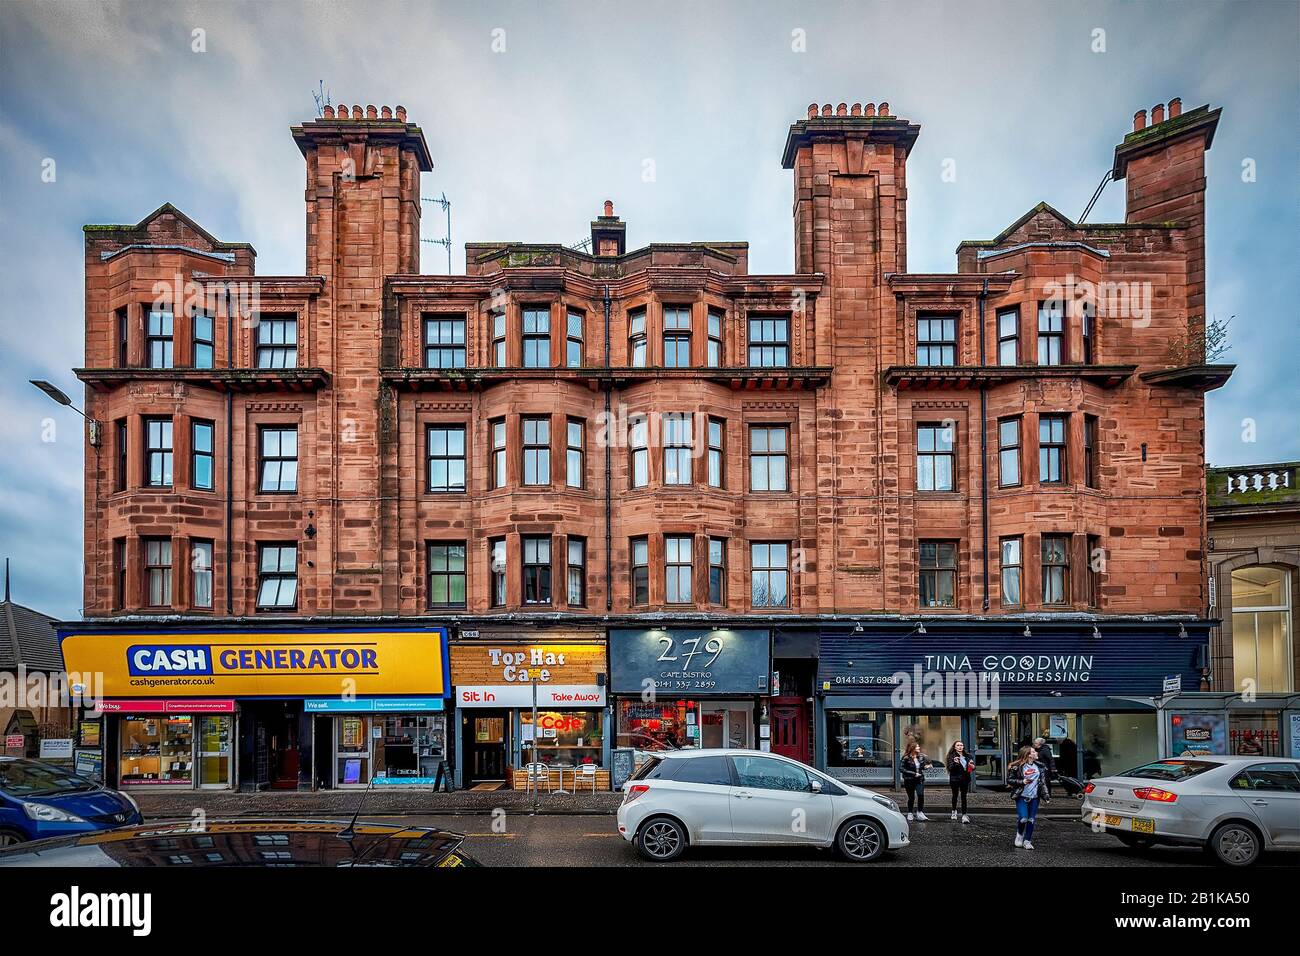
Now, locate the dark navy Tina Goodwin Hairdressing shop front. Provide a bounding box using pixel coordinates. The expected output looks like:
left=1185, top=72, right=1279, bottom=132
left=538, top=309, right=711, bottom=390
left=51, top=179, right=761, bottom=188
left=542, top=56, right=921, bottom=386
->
left=816, top=622, right=1208, bottom=787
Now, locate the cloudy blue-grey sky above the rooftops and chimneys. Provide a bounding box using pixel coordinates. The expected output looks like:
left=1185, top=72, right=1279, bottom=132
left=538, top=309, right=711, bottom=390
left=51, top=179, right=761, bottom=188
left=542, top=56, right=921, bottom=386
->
left=0, top=0, right=1300, bottom=617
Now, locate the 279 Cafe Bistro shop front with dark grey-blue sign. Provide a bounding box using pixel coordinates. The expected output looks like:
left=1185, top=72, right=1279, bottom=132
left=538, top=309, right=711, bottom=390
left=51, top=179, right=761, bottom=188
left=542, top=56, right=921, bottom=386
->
left=610, top=628, right=772, bottom=752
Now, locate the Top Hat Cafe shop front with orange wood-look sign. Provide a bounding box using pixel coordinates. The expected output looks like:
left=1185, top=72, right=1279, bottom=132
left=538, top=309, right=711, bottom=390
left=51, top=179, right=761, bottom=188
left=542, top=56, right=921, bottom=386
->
left=451, top=636, right=610, bottom=792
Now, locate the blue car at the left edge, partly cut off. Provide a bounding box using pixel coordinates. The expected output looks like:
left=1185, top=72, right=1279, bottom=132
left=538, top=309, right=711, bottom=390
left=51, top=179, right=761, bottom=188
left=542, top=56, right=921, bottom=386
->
left=0, top=757, right=143, bottom=847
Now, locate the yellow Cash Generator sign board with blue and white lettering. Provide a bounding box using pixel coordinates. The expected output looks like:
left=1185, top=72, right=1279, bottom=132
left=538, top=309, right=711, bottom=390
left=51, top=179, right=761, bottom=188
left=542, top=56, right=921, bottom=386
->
left=62, top=628, right=447, bottom=697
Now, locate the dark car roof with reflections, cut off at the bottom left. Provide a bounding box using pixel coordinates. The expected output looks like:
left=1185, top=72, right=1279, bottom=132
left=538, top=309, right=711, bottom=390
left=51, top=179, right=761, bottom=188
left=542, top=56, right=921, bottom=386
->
left=0, top=819, right=480, bottom=869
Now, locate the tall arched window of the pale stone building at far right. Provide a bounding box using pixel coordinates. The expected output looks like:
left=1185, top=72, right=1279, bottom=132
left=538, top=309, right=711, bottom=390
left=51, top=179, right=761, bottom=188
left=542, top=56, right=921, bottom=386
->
left=1232, top=566, right=1295, bottom=693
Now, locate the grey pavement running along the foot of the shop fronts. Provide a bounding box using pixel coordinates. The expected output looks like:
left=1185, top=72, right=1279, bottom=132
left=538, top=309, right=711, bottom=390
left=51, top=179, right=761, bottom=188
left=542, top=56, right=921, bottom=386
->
left=131, top=787, right=1080, bottom=818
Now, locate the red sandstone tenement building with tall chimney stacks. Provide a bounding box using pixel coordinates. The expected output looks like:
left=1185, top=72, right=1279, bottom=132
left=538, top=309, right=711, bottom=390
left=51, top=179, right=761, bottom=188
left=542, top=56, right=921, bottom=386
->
left=69, top=100, right=1258, bottom=787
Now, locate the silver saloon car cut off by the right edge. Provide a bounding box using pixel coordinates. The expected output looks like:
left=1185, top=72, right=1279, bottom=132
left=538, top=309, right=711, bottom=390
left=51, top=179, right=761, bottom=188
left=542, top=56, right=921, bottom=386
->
left=1082, top=756, right=1300, bottom=866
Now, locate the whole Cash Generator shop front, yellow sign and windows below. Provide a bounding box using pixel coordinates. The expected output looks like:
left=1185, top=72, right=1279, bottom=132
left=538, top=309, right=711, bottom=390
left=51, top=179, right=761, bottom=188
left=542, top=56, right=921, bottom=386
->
left=60, top=624, right=447, bottom=790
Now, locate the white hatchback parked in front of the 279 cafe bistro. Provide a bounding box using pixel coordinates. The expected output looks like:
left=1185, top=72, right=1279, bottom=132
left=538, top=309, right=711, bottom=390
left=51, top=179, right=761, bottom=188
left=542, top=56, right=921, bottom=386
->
left=619, top=749, right=907, bottom=862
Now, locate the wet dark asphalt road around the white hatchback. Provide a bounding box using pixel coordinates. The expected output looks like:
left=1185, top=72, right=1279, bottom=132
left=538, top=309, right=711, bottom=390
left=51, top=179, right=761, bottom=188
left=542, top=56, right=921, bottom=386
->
left=374, top=813, right=1295, bottom=868
